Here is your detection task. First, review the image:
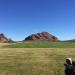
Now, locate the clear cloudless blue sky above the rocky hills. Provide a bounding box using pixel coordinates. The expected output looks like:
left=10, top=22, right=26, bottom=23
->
left=0, top=0, right=75, bottom=40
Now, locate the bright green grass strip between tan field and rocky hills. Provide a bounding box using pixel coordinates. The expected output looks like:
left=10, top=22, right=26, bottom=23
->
left=5, top=41, right=75, bottom=48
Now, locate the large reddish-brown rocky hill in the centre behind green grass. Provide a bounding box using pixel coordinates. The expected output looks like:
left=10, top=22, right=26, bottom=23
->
left=24, top=32, right=58, bottom=41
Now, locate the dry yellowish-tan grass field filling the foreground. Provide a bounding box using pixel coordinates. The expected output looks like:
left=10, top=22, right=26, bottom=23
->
left=0, top=48, right=75, bottom=75
